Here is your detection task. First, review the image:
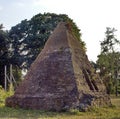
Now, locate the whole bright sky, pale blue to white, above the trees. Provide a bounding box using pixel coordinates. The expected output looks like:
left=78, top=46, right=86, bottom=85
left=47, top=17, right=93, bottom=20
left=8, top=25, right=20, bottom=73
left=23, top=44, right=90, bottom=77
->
left=0, top=0, right=120, bottom=62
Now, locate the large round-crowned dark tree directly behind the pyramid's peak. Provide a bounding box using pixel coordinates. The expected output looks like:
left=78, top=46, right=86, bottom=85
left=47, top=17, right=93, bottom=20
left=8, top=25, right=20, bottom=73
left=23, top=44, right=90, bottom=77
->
left=9, top=13, right=85, bottom=69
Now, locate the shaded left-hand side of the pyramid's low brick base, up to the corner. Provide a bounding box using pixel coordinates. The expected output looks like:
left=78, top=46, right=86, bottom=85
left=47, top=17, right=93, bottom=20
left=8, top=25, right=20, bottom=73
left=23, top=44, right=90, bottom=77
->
left=6, top=96, right=78, bottom=111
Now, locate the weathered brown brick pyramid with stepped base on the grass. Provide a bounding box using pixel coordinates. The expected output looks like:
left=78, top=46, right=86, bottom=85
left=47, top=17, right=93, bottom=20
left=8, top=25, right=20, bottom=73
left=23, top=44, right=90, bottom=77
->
left=6, top=22, right=110, bottom=111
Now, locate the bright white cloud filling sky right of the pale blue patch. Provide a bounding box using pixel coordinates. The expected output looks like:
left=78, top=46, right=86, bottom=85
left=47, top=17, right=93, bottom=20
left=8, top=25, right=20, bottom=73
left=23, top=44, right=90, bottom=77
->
left=29, top=0, right=120, bottom=61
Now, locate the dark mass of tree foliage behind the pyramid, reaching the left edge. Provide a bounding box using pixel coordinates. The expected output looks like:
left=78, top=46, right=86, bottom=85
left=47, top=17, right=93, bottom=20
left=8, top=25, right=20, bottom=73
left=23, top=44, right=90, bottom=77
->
left=0, top=13, right=85, bottom=86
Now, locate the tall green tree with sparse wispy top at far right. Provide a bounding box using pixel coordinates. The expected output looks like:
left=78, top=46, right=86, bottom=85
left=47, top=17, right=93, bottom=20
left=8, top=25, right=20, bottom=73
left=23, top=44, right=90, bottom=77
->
left=97, top=27, right=120, bottom=95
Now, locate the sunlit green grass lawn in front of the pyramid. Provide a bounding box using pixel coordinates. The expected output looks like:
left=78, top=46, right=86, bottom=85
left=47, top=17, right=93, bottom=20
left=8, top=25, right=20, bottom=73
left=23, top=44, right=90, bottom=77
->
left=0, top=97, right=120, bottom=119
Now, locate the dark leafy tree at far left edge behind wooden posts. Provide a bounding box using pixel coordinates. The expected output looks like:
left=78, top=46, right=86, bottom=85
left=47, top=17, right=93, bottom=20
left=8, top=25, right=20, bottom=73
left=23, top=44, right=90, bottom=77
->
left=0, top=24, right=22, bottom=87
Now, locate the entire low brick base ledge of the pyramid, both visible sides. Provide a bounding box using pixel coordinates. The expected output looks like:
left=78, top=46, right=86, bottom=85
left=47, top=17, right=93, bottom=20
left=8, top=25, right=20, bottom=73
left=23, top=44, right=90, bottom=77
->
left=6, top=94, right=111, bottom=111
